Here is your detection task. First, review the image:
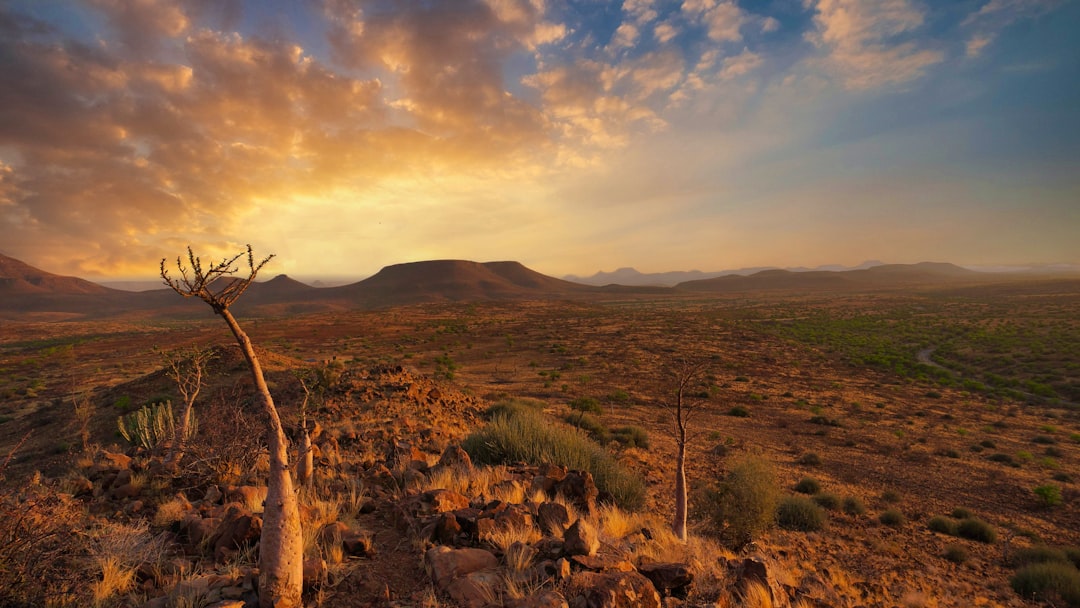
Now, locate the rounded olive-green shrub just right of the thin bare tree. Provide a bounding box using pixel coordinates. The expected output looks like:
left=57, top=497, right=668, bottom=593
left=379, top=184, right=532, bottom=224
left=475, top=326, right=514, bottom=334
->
left=702, top=456, right=780, bottom=546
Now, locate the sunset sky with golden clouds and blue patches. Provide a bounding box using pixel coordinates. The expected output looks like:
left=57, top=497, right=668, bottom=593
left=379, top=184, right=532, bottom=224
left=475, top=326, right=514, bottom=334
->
left=0, top=0, right=1080, bottom=279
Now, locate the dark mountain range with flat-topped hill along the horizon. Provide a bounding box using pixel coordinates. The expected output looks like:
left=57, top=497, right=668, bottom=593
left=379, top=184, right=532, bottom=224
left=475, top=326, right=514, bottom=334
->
left=0, top=255, right=1080, bottom=319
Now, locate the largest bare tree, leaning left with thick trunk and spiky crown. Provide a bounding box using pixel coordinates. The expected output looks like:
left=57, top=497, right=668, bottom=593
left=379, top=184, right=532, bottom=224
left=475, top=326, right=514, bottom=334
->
left=161, top=245, right=303, bottom=608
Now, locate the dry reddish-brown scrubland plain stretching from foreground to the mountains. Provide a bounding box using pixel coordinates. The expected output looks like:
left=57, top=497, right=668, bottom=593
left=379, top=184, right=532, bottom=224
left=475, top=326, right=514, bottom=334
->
left=0, top=287, right=1080, bottom=607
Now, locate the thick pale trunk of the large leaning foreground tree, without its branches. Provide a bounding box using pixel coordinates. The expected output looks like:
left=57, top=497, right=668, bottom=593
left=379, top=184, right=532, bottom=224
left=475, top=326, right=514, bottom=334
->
left=215, top=308, right=303, bottom=608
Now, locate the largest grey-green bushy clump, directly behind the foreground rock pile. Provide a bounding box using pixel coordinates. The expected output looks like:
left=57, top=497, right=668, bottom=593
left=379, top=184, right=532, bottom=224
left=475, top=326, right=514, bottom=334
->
left=461, top=407, right=645, bottom=511
